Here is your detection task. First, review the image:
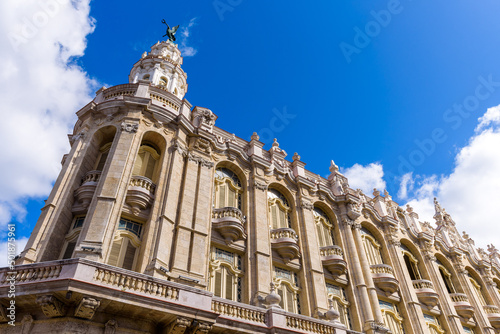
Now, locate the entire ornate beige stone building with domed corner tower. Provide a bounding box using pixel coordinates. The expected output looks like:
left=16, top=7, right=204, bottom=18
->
left=0, top=42, right=500, bottom=334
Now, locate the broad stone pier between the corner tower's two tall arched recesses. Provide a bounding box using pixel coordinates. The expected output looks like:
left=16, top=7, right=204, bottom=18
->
left=75, top=119, right=141, bottom=261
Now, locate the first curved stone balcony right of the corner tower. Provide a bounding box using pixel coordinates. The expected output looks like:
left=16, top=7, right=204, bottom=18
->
left=212, top=207, right=247, bottom=244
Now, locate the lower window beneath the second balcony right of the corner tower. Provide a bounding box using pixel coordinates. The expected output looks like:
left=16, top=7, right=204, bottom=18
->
left=274, top=267, right=300, bottom=314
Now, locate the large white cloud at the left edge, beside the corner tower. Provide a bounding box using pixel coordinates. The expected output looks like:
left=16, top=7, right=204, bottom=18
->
left=0, top=0, right=95, bottom=225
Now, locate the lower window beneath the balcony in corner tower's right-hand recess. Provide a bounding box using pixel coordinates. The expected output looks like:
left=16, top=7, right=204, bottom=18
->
left=108, top=218, right=142, bottom=270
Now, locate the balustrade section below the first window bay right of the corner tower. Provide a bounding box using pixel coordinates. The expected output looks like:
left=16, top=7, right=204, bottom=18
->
left=212, top=297, right=266, bottom=324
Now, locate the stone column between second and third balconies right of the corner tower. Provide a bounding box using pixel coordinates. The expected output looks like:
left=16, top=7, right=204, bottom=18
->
left=297, top=199, right=328, bottom=316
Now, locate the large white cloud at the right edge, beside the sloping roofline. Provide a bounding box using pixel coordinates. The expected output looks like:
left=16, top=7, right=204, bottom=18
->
left=400, top=106, right=500, bottom=248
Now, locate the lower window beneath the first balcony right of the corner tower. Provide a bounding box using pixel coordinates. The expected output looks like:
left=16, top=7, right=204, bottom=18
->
left=209, top=247, right=243, bottom=302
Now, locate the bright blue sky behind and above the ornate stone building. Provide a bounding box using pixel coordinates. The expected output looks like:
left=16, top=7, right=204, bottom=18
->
left=0, top=0, right=500, bottom=258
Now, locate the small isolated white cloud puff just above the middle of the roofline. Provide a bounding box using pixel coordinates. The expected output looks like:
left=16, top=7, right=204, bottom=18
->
left=342, top=163, right=386, bottom=194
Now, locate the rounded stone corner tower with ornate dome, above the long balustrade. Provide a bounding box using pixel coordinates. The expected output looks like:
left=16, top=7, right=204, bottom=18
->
left=18, top=41, right=216, bottom=282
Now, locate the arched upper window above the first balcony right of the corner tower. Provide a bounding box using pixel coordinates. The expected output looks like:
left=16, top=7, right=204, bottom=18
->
left=214, top=168, right=243, bottom=210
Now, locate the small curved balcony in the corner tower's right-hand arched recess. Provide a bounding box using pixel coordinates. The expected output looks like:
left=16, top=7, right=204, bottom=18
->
left=125, top=176, right=156, bottom=216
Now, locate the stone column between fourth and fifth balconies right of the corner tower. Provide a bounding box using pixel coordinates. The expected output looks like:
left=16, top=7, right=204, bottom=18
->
left=387, top=231, right=429, bottom=333
